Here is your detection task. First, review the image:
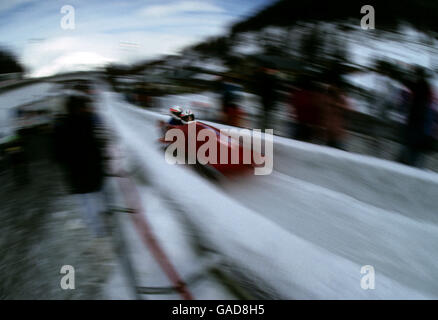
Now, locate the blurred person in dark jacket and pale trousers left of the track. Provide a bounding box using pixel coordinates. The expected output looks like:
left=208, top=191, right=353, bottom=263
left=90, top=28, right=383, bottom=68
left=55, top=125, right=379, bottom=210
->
left=54, top=95, right=104, bottom=236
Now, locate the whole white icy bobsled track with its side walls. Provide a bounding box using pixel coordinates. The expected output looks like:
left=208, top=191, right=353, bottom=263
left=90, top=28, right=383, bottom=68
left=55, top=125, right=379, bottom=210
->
left=99, top=88, right=438, bottom=299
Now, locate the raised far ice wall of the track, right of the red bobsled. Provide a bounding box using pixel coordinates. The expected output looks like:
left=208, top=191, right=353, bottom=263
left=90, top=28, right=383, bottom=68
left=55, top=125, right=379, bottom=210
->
left=274, top=137, right=438, bottom=224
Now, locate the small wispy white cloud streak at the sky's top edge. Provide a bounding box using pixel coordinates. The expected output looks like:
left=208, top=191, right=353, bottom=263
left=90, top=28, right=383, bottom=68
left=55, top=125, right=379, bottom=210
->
left=141, top=1, right=225, bottom=18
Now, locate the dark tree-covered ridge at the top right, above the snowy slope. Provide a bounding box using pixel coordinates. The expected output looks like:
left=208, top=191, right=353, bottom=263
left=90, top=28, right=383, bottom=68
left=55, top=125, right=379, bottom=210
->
left=231, top=0, right=438, bottom=35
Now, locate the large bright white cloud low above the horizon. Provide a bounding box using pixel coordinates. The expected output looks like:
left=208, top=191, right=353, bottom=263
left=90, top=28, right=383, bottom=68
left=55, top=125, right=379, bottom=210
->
left=22, top=32, right=196, bottom=77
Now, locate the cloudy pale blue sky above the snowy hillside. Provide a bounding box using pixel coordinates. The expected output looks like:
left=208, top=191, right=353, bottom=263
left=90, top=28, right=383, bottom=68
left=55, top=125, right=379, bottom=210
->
left=0, top=0, right=274, bottom=77
